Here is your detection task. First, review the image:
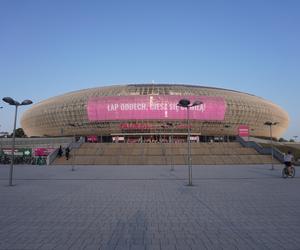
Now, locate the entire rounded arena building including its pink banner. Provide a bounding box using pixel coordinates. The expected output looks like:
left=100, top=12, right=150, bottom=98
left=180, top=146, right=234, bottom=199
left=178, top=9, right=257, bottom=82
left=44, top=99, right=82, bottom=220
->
left=21, top=84, right=289, bottom=142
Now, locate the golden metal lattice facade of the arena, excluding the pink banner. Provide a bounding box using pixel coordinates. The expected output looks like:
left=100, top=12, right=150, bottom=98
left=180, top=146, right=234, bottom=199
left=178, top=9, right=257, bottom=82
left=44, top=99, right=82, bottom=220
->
left=21, top=84, right=289, bottom=138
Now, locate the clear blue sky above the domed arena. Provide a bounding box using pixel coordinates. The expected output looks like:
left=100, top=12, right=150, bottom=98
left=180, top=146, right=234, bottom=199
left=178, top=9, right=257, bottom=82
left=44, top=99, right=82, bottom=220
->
left=0, top=0, right=300, bottom=139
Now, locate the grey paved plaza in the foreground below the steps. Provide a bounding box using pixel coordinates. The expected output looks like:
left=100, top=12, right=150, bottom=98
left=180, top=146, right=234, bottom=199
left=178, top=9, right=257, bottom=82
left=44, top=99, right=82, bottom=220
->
left=0, top=165, right=300, bottom=250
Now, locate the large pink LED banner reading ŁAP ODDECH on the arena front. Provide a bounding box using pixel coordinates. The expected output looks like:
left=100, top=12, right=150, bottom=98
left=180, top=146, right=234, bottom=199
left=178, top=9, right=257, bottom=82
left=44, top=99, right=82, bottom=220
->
left=87, top=95, right=226, bottom=121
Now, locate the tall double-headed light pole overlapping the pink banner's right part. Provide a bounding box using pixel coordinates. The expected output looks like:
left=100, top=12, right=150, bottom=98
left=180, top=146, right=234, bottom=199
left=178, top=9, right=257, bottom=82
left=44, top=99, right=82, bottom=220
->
left=177, top=99, right=202, bottom=186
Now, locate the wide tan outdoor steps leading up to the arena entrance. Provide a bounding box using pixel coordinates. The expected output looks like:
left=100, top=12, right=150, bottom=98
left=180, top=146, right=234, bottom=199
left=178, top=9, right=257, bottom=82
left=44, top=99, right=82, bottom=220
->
left=52, top=142, right=279, bottom=165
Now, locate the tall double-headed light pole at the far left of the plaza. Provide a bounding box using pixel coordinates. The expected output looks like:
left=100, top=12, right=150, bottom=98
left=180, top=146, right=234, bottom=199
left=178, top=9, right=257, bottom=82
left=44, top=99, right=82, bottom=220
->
left=2, top=97, right=32, bottom=186
